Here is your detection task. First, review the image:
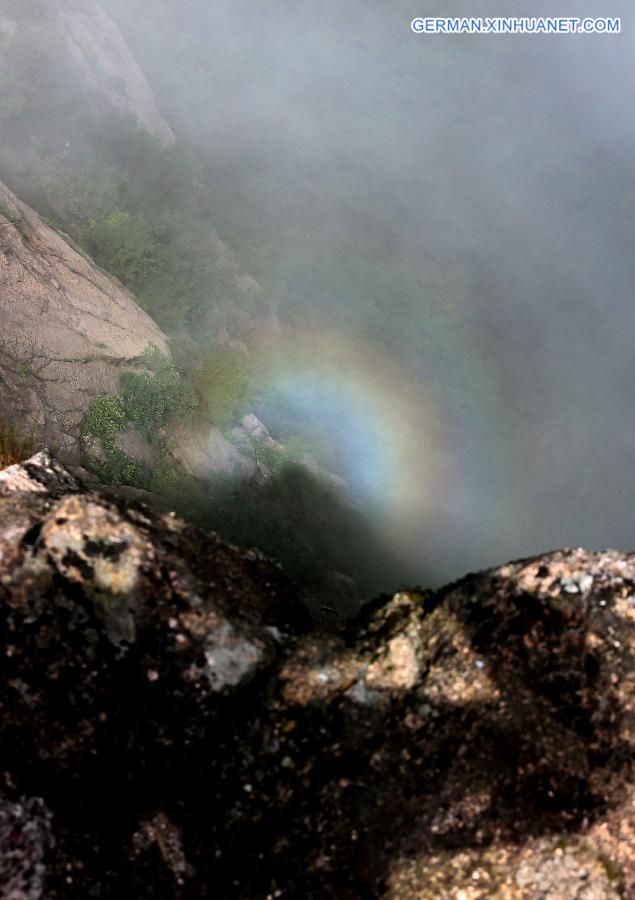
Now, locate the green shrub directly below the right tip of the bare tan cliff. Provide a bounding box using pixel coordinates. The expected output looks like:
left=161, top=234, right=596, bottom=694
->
left=120, top=348, right=197, bottom=441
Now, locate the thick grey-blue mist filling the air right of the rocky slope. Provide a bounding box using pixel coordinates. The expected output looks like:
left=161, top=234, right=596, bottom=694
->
left=4, top=0, right=635, bottom=583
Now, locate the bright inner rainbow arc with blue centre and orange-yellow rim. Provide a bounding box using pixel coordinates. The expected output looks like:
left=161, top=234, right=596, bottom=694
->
left=252, top=331, right=457, bottom=552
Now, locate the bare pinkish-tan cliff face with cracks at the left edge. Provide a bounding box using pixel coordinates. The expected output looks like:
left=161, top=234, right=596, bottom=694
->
left=0, top=182, right=169, bottom=464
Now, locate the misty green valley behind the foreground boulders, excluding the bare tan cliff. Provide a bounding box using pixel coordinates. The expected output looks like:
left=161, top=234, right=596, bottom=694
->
left=0, top=0, right=635, bottom=610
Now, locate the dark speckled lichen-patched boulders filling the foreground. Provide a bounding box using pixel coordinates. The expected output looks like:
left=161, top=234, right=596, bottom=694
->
left=0, top=455, right=635, bottom=900
